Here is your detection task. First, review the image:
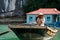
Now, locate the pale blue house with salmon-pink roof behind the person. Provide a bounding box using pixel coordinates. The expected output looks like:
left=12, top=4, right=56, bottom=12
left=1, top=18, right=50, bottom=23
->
left=26, top=8, right=60, bottom=25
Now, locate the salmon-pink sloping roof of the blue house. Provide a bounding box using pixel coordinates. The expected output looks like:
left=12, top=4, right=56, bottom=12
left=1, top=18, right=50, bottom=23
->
left=27, top=8, right=60, bottom=14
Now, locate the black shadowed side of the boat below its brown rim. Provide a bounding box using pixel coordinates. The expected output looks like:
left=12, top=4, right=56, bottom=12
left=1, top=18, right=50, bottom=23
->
left=11, top=28, right=46, bottom=40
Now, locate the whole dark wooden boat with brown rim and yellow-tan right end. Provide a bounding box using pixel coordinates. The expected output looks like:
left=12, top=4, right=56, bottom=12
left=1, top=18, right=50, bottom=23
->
left=9, top=24, right=58, bottom=40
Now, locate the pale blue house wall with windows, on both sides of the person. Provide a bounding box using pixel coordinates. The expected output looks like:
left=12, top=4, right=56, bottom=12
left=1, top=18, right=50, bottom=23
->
left=27, top=14, right=56, bottom=24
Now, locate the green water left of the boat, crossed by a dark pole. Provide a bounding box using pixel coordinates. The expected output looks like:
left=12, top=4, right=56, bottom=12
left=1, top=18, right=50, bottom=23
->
left=0, top=25, right=19, bottom=40
